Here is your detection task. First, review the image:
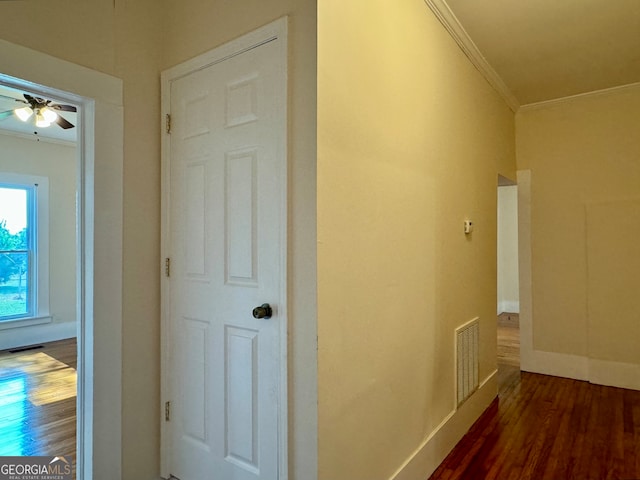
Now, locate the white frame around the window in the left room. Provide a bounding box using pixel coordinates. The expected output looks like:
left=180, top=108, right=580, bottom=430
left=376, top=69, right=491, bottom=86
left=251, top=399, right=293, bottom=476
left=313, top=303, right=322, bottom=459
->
left=0, top=172, right=52, bottom=330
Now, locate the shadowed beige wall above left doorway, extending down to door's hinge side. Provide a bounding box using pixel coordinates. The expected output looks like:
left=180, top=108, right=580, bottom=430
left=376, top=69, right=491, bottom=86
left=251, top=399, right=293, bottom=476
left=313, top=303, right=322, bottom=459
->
left=0, top=0, right=162, bottom=480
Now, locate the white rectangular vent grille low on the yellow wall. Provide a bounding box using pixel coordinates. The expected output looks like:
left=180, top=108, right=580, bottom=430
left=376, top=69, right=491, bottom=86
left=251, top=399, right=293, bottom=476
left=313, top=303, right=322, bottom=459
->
left=456, top=318, right=480, bottom=406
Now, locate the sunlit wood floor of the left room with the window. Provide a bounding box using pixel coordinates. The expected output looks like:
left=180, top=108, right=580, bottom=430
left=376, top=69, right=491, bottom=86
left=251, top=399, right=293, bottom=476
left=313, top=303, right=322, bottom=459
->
left=0, top=339, right=77, bottom=460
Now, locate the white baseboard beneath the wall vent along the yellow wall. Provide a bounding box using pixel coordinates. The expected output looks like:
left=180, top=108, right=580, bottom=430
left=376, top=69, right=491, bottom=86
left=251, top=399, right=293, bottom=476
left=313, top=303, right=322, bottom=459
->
left=390, top=371, right=498, bottom=480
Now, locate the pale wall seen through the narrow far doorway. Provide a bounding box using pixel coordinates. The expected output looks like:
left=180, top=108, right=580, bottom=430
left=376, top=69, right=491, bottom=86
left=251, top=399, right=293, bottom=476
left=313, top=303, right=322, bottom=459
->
left=498, top=185, right=520, bottom=313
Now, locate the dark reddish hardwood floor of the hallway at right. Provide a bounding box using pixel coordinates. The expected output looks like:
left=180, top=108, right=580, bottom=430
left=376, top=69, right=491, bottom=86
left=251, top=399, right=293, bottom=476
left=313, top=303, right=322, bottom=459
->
left=430, top=316, right=640, bottom=480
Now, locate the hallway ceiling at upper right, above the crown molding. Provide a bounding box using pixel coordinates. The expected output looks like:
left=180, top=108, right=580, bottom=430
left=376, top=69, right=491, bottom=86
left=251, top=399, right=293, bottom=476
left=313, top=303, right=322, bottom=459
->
left=426, top=0, right=640, bottom=109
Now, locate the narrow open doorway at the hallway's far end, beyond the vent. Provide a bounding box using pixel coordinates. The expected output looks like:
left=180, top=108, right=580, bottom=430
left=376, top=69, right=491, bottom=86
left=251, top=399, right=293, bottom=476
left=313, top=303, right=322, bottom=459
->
left=497, top=175, right=520, bottom=387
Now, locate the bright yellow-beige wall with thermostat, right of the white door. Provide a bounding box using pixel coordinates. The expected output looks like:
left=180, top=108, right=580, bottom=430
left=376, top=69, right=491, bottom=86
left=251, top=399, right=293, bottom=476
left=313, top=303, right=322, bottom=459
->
left=318, top=0, right=515, bottom=480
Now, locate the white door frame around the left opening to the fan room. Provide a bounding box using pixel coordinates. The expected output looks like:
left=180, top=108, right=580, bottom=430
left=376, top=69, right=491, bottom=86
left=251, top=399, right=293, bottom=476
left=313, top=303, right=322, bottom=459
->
left=0, top=40, right=124, bottom=480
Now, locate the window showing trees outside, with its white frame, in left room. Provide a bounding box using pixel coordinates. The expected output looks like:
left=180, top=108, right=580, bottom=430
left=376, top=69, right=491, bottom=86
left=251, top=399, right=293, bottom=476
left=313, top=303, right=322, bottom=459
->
left=0, top=173, right=51, bottom=326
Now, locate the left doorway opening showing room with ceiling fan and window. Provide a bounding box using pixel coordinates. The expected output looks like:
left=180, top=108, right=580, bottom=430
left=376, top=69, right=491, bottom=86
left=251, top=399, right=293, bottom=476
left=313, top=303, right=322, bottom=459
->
left=0, top=75, right=84, bottom=471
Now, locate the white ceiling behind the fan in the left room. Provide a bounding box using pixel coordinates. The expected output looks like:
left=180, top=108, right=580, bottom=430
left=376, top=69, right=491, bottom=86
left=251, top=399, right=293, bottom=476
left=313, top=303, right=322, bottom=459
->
left=0, top=84, right=78, bottom=143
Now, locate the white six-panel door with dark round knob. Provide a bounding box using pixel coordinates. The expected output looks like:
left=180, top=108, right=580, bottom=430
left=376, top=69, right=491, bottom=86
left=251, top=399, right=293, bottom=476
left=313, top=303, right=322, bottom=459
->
left=163, top=19, right=286, bottom=480
